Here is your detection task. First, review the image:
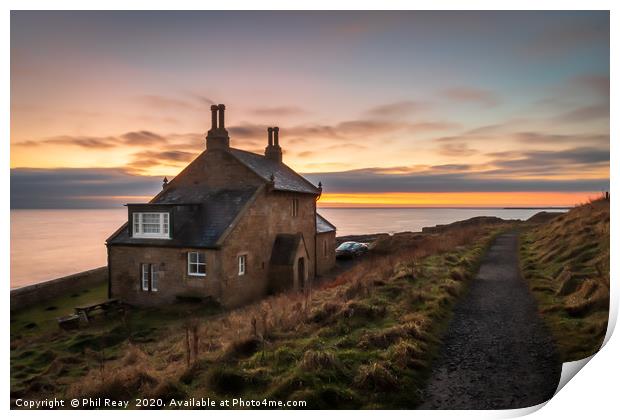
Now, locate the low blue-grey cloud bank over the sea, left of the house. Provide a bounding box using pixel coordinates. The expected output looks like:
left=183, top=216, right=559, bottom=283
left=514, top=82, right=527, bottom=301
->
left=11, top=168, right=161, bottom=209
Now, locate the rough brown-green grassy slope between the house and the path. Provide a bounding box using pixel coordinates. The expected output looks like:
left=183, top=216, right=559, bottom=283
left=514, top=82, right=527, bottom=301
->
left=11, top=221, right=508, bottom=408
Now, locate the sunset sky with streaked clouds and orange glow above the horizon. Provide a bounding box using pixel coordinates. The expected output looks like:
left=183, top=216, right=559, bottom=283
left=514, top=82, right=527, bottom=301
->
left=11, top=11, right=609, bottom=208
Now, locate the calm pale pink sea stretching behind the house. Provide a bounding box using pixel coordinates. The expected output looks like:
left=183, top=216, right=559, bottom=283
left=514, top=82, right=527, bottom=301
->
left=11, top=209, right=568, bottom=288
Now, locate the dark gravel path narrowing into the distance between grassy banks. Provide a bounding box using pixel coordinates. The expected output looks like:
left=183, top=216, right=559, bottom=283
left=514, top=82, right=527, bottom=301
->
left=419, top=233, right=562, bottom=409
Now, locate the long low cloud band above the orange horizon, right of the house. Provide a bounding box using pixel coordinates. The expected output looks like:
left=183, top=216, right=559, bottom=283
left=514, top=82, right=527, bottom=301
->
left=306, top=147, right=609, bottom=193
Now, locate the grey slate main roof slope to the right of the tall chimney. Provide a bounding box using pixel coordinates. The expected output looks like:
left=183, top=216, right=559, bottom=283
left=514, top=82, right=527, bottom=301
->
left=230, top=148, right=321, bottom=194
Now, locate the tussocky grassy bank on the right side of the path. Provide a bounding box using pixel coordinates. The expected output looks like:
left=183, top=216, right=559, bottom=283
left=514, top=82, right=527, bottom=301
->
left=521, top=200, right=609, bottom=361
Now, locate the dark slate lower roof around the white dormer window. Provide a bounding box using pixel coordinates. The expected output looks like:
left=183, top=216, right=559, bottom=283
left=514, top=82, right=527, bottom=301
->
left=108, top=185, right=257, bottom=248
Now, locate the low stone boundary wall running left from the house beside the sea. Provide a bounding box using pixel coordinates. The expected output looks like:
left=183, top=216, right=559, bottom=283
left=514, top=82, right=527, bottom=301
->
left=11, top=266, right=108, bottom=310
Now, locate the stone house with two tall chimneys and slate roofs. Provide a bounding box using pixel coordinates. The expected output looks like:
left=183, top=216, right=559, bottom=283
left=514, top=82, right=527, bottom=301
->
left=106, top=105, right=336, bottom=307
